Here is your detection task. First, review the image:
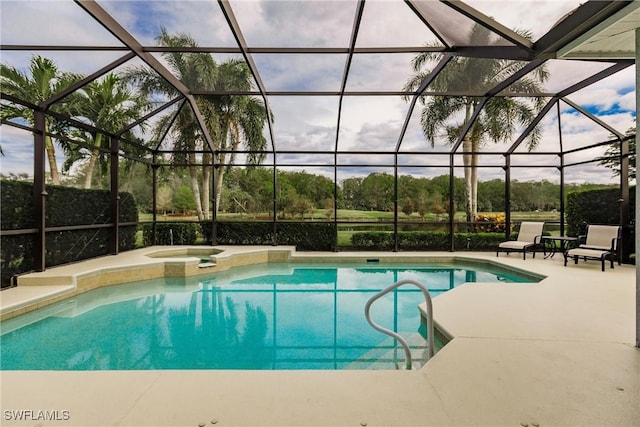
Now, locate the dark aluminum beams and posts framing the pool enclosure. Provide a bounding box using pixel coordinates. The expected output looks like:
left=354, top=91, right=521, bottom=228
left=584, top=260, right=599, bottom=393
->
left=0, top=0, right=640, bottom=345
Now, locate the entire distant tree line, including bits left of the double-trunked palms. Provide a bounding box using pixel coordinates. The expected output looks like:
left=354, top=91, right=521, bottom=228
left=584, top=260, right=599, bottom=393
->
left=0, top=165, right=617, bottom=218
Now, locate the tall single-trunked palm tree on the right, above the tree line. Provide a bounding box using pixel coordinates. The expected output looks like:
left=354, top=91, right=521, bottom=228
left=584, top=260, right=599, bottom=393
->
left=404, top=25, right=548, bottom=227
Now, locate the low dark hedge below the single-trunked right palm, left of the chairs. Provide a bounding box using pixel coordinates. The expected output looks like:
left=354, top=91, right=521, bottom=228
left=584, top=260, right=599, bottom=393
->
left=351, top=231, right=504, bottom=251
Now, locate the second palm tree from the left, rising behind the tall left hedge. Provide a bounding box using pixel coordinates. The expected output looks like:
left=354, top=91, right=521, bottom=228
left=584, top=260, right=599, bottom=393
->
left=63, top=74, right=147, bottom=188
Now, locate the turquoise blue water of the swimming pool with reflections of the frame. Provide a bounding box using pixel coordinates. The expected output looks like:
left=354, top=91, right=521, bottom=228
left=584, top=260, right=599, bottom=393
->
left=0, top=264, right=536, bottom=370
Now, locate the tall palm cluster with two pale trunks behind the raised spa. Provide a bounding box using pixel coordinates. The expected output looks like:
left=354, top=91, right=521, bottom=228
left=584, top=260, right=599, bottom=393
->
left=127, top=29, right=266, bottom=220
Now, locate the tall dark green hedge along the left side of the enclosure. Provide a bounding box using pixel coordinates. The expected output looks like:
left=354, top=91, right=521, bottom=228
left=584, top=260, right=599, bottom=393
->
left=0, top=180, right=138, bottom=287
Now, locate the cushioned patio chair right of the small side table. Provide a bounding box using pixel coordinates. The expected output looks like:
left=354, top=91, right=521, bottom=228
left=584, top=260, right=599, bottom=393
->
left=564, top=225, right=621, bottom=271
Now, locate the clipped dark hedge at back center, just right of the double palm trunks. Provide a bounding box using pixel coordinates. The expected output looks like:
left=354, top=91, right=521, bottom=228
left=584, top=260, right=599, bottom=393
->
left=201, top=221, right=336, bottom=251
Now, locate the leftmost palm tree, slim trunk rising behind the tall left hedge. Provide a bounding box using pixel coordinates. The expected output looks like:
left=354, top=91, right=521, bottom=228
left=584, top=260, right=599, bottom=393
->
left=0, top=55, right=82, bottom=185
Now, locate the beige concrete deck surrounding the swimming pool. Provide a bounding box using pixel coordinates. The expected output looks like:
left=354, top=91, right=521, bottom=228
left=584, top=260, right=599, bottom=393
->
left=0, top=247, right=640, bottom=426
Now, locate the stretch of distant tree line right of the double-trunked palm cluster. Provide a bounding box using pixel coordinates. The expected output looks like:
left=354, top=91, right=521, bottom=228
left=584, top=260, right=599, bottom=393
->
left=210, top=167, right=615, bottom=218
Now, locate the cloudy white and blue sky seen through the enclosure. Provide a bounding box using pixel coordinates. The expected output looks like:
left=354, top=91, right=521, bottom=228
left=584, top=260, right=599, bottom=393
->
left=0, top=0, right=636, bottom=182
